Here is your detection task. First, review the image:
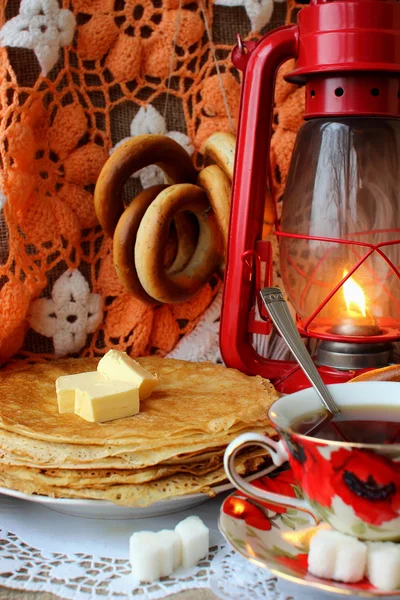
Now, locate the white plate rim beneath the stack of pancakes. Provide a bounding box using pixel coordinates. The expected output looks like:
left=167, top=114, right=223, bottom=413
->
left=0, top=465, right=276, bottom=519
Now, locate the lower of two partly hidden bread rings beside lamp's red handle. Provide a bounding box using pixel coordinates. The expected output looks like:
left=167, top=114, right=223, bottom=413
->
left=197, top=165, right=231, bottom=250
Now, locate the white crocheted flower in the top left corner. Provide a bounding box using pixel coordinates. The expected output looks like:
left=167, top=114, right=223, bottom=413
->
left=0, top=0, right=75, bottom=75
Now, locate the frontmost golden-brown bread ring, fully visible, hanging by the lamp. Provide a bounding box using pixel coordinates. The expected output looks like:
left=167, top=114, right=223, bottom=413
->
left=135, top=183, right=223, bottom=303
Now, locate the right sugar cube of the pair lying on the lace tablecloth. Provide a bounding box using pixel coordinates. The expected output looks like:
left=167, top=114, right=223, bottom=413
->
left=175, top=516, right=210, bottom=569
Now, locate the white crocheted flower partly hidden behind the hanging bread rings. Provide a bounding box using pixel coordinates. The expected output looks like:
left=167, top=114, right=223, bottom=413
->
left=110, top=104, right=194, bottom=189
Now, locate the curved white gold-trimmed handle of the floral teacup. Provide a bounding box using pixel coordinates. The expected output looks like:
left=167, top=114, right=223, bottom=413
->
left=224, top=433, right=310, bottom=512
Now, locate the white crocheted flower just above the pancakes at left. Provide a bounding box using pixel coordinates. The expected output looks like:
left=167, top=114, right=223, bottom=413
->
left=28, top=270, right=103, bottom=356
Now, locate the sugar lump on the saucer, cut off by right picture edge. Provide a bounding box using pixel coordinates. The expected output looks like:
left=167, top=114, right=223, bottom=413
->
left=367, top=542, right=400, bottom=592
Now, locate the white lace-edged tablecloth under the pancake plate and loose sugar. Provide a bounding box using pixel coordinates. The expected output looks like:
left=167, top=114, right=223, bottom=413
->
left=0, top=496, right=304, bottom=600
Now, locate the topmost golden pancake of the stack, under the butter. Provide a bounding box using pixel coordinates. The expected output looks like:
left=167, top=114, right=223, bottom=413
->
left=0, top=356, right=277, bottom=446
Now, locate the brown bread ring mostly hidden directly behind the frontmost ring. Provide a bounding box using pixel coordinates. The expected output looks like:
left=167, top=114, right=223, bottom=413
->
left=113, top=185, right=196, bottom=304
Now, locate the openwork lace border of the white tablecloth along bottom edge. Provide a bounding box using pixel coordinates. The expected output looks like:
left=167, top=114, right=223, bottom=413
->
left=0, top=529, right=300, bottom=600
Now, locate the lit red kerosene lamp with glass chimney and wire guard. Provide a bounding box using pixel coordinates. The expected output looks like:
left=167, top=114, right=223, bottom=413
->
left=220, top=0, right=400, bottom=392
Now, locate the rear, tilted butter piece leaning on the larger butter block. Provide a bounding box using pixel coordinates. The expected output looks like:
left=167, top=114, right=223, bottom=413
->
left=97, top=350, right=157, bottom=400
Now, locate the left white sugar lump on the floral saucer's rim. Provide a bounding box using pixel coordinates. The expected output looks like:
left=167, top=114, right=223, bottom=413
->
left=308, top=529, right=367, bottom=583
